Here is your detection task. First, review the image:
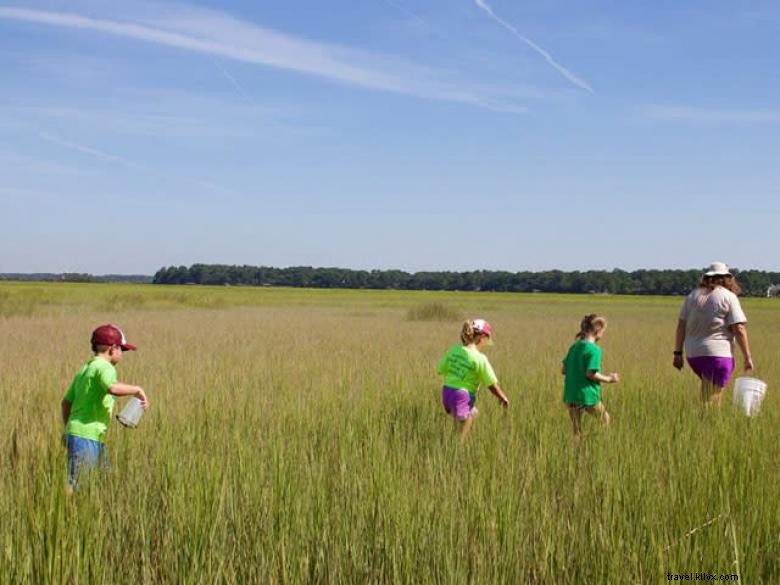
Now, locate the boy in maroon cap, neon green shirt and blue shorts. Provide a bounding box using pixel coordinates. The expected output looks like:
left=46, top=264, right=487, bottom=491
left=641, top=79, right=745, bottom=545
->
left=62, top=325, right=149, bottom=494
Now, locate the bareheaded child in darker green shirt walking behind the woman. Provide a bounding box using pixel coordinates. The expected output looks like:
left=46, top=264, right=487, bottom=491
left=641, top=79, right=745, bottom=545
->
left=561, top=314, right=620, bottom=445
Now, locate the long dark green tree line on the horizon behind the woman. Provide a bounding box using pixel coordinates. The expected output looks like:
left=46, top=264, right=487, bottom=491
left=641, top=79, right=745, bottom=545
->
left=153, top=264, right=780, bottom=296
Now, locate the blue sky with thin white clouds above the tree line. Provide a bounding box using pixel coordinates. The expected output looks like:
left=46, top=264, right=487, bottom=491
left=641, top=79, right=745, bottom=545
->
left=0, top=0, right=780, bottom=274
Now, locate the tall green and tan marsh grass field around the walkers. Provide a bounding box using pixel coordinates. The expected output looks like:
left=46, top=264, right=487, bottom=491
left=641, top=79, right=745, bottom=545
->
left=0, top=283, right=780, bottom=585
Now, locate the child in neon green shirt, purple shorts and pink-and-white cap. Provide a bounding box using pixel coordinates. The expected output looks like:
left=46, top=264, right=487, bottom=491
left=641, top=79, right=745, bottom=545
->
left=438, top=319, right=509, bottom=442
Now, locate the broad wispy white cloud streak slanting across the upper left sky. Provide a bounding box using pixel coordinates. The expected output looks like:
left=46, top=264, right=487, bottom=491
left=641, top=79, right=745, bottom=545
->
left=0, top=7, right=523, bottom=111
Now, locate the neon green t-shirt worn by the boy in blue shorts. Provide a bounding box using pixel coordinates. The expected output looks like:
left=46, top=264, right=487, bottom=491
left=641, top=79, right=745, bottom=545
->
left=65, top=356, right=117, bottom=442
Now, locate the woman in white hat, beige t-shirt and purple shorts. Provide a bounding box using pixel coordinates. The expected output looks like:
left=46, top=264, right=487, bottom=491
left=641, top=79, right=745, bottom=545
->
left=674, top=262, right=753, bottom=406
